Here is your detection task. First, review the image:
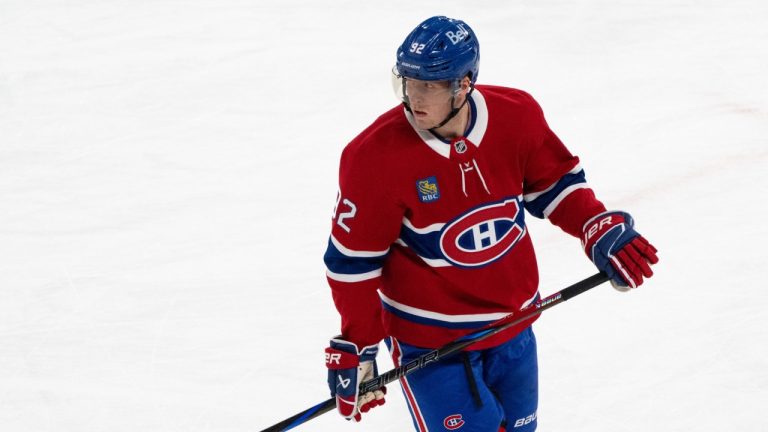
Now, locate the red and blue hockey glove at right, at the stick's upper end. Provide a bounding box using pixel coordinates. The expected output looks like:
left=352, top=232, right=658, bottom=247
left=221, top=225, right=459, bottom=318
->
left=581, top=211, right=659, bottom=291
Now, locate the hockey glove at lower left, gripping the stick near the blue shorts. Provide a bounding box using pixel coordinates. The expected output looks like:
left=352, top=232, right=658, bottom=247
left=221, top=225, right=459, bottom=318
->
left=325, top=336, right=387, bottom=422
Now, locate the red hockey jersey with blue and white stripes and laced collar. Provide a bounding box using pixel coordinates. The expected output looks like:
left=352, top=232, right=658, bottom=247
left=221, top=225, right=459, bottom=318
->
left=325, top=85, right=605, bottom=350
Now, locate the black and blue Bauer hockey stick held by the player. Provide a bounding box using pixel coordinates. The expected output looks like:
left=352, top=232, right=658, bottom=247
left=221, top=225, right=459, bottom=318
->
left=261, top=272, right=608, bottom=432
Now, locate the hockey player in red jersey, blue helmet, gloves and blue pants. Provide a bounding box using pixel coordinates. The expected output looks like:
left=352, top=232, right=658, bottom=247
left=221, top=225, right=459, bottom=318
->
left=325, top=16, right=658, bottom=432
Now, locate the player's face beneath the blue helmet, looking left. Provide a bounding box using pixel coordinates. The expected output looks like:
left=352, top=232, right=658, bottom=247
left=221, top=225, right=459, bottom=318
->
left=405, top=79, right=454, bottom=129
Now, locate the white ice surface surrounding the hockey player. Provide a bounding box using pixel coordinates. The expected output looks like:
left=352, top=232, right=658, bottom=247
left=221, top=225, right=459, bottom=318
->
left=0, top=0, right=768, bottom=432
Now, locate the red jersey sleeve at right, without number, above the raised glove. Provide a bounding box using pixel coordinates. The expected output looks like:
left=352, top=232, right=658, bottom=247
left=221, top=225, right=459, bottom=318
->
left=523, top=95, right=605, bottom=237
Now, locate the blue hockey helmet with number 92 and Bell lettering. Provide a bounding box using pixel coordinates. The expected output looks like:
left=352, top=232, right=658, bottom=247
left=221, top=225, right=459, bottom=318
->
left=395, top=16, right=480, bottom=86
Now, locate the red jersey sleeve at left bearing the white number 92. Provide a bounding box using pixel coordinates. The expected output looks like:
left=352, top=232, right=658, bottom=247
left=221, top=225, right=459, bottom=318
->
left=324, top=141, right=403, bottom=346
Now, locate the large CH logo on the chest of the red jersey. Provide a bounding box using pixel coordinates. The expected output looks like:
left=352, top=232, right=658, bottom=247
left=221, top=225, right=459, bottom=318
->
left=440, top=198, right=525, bottom=267
